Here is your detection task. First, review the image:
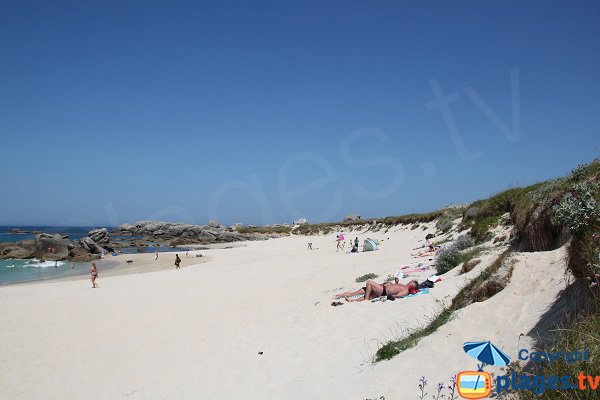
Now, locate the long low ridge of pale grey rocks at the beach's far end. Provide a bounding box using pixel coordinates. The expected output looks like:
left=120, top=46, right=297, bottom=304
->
left=113, top=221, right=264, bottom=244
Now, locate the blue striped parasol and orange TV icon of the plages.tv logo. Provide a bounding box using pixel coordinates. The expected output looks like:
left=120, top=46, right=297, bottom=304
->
left=456, top=341, right=510, bottom=399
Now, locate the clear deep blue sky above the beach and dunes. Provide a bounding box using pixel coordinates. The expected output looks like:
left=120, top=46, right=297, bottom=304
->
left=0, top=0, right=600, bottom=225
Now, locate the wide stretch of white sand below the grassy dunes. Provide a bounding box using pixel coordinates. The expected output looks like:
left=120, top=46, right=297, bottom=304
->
left=0, top=224, right=568, bottom=400
